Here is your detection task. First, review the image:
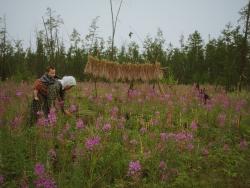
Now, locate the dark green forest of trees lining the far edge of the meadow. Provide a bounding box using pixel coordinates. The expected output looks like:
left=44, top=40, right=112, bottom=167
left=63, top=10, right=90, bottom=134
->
left=0, top=2, right=250, bottom=91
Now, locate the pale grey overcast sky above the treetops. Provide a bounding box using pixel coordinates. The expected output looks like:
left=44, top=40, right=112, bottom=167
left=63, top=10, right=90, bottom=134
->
left=0, top=0, right=248, bottom=48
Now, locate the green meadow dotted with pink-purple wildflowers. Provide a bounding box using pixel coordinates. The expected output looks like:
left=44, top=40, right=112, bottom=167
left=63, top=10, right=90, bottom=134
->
left=0, top=82, right=250, bottom=188
